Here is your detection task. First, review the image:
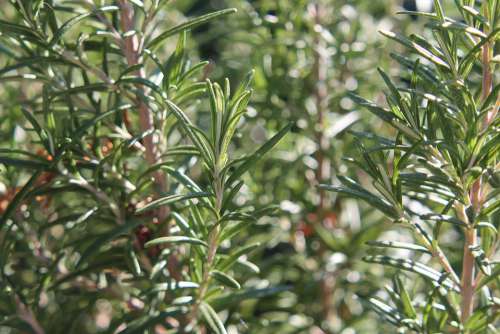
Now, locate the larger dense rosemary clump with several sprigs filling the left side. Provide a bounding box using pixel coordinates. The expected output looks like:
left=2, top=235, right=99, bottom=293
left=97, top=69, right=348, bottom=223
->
left=0, top=0, right=290, bottom=334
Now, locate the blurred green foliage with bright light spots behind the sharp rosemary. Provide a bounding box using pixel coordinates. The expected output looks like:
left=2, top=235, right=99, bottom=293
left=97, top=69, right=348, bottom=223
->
left=0, top=0, right=464, bottom=334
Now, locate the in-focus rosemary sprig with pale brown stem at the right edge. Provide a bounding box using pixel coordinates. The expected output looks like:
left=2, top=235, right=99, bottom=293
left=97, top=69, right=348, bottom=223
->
left=322, top=0, right=500, bottom=333
